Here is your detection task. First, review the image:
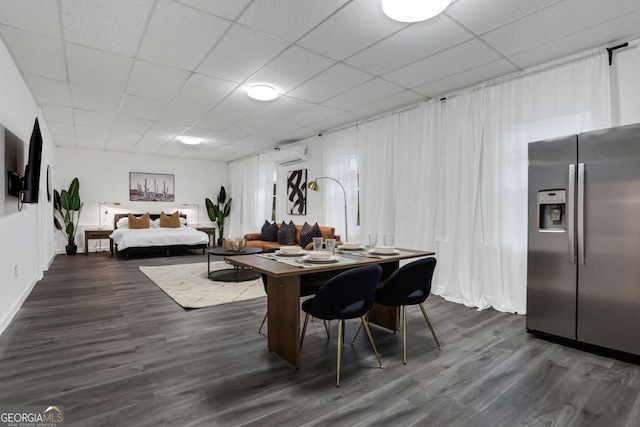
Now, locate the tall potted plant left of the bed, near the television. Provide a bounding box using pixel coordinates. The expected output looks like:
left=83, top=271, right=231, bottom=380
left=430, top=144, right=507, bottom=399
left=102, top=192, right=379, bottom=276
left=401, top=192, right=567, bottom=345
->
left=53, top=178, right=82, bottom=255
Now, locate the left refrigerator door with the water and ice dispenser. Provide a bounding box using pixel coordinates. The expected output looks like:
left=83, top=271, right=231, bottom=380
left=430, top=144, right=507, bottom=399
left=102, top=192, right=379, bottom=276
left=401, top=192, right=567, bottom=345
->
left=527, top=135, right=578, bottom=339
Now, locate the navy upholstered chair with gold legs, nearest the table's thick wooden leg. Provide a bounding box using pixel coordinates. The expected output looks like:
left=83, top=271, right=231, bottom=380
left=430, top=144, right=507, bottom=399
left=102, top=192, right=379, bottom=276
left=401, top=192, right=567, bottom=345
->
left=300, top=265, right=382, bottom=387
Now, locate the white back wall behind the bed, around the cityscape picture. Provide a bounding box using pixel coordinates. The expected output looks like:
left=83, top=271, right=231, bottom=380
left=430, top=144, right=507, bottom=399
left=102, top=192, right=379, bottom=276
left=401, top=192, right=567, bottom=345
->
left=54, top=147, right=228, bottom=253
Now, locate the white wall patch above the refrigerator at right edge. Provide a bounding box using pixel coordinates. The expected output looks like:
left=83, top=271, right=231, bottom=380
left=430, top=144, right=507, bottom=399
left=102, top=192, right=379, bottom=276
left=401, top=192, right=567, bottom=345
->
left=611, top=39, right=640, bottom=126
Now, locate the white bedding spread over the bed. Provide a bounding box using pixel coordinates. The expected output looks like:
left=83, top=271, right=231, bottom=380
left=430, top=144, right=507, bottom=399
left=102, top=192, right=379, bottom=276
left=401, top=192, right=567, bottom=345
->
left=110, top=227, right=209, bottom=251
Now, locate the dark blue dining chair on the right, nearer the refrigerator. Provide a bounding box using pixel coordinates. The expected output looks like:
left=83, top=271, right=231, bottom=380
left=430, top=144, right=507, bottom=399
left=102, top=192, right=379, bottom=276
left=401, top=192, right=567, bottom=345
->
left=351, top=258, right=441, bottom=364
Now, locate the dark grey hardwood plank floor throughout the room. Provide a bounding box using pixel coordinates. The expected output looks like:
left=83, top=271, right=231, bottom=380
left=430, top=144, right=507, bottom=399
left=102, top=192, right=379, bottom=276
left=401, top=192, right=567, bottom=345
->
left=0, top=253, right=640, bottom=427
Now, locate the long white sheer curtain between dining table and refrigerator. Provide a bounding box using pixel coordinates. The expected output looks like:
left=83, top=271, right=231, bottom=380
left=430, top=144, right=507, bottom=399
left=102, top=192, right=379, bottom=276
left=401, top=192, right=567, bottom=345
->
left=323, top=53, right=611, bottom=313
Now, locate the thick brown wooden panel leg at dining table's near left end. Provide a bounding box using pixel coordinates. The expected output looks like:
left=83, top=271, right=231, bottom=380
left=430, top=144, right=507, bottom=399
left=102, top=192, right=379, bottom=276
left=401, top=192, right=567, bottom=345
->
left=267, top=276, right=300, bottom=369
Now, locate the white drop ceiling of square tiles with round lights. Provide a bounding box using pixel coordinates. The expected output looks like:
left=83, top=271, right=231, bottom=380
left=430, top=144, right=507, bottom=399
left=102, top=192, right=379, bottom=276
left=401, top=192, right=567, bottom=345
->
left=0, top=0, right=640, bottom=161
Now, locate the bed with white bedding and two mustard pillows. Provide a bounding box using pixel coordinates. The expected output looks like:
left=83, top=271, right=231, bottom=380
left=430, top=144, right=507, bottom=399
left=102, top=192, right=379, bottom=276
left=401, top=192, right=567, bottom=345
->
left=109, top=214, right=209, bottom=259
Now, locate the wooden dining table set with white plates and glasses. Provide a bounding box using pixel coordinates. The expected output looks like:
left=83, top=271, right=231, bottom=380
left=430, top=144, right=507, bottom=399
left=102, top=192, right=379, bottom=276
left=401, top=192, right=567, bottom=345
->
left=224, top=249, right=435, bottom=368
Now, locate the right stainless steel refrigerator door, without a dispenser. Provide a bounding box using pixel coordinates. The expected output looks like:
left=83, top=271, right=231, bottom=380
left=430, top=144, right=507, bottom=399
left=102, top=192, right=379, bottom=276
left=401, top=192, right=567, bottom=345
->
left=577, top=125, right=640, bottom=354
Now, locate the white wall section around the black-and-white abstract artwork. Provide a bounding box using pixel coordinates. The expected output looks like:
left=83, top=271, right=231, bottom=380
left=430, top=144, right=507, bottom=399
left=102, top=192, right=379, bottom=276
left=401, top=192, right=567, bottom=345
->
left=276, top=136, right=330, bottom=229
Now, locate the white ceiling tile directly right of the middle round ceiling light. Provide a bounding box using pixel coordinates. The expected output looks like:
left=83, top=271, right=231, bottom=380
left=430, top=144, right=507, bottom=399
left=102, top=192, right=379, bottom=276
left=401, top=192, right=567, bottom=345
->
left=288, top=63, right=371, bottom=102
